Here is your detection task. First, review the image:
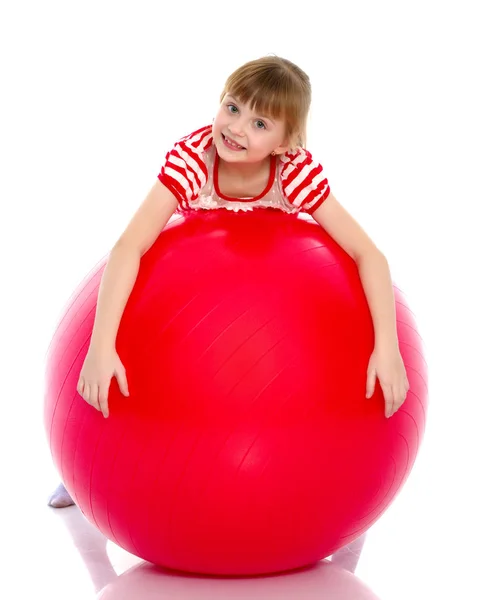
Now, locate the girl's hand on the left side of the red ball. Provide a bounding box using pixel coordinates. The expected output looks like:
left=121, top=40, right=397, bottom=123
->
left=77, top=346, right=129, bottom=419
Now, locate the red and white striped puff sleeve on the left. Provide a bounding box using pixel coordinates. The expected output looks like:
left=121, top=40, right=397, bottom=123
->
left=158, top=125, right=213, bottom=209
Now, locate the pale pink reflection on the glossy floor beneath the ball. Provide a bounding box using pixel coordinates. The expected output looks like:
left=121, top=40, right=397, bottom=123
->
left=51, top=506, right=378, bottom=600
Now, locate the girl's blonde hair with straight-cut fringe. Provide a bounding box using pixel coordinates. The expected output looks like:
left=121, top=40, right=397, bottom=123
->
left=220, top=56, right=311, bottom=149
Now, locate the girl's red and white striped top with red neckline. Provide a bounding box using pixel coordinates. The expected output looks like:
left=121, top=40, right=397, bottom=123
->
left=158, top=125, right=330, bottom=214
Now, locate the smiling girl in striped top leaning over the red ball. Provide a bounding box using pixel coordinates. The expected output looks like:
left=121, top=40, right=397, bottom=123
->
left=50, top=56, right=409, bottom=507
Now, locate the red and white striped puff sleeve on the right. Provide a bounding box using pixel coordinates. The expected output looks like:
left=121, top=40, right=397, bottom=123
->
left=280, top=148, right=331, bottom=214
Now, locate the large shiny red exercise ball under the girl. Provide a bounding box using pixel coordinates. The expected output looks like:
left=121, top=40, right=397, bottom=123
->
left=45, top=209, right=427, bottom=575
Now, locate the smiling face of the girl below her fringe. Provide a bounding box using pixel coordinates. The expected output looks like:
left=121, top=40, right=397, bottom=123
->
left=213, top=94, right=288, bottom=163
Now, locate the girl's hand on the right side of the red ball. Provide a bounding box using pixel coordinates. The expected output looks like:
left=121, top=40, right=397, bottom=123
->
left=366, top=346, right=409, bottom=418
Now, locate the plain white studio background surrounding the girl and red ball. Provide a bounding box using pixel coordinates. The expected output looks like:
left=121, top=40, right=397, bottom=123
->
left=0, top=0, right=479, bottom=600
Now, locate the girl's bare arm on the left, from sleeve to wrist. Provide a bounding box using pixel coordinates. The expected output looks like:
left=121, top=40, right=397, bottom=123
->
left=90, top=180, right=178, bottom=350
